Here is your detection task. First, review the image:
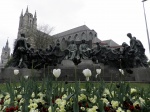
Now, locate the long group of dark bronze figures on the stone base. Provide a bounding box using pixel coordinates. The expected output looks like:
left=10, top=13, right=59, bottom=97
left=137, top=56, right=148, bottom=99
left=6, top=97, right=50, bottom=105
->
left=9, top=33, right=148, bottom=69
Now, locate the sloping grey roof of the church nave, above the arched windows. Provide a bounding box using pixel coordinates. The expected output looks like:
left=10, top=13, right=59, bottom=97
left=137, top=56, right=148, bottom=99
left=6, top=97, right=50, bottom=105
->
left=53, top=25, right=90, bottom=38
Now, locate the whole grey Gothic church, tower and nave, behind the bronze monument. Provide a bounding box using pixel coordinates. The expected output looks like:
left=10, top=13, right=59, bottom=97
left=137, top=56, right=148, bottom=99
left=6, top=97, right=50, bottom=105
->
left=17, top=7, right=119, bottom=49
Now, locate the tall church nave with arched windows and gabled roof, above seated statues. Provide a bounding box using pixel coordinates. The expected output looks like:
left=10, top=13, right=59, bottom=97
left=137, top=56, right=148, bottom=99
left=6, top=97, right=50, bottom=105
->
left=53, top=25, right=99, bottom=49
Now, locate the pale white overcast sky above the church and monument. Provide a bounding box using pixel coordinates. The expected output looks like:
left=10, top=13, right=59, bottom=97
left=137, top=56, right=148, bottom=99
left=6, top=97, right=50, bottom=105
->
left=0, top=0, right=150, bottom=59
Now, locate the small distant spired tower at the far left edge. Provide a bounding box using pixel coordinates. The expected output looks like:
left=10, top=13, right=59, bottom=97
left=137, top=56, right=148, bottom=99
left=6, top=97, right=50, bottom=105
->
left=1, top=40, right=10, bottom=67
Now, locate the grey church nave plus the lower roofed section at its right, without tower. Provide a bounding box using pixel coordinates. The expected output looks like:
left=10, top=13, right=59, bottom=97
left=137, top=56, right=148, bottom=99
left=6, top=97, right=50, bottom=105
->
left=53, top=25, right=121, bottom=49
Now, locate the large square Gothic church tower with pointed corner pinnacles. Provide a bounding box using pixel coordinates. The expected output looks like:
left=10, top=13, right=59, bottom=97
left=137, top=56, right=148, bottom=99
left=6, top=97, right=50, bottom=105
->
left=17, top=7, right=37, bottom=46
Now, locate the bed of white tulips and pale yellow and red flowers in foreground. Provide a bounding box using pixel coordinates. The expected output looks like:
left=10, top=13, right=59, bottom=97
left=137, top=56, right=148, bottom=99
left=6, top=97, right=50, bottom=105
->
left=0, top=69, right=150, bottom=112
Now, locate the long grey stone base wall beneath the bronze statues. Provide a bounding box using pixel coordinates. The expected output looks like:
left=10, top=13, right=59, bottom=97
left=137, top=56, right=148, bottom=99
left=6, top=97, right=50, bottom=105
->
left=0, top=60, right=150, bottom=82
